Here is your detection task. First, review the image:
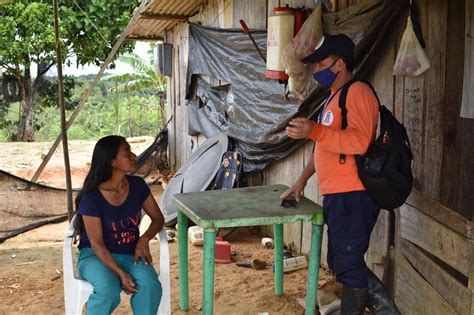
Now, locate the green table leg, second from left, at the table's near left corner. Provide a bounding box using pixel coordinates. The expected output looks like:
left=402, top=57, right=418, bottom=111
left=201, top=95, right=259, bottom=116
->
left=202, top=228, right=217, bottom=315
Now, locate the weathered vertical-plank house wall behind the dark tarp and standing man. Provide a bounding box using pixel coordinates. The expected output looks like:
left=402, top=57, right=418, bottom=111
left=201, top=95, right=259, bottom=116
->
left=167, top=0, right=474, bottom=276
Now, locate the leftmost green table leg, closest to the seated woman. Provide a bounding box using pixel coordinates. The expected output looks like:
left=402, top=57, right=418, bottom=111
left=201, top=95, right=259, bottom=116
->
left=178, top=211, right=189, bottom=311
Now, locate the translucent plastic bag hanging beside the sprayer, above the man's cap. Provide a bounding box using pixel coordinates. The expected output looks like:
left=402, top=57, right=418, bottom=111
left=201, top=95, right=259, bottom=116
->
left=281, top=5, right=323, bottom=100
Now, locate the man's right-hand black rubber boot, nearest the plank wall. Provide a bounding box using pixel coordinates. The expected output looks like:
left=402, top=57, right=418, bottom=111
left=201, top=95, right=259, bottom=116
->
left=367, top=268, right=400, bottom=315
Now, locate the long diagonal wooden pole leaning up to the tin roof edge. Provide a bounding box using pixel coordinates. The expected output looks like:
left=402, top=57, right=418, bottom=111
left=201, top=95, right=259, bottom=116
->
left=31, top=0, right=148, bottom=183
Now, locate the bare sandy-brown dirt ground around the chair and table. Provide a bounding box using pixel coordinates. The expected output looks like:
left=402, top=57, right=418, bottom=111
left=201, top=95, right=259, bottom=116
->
left=0, top=138, right=332, bottom=315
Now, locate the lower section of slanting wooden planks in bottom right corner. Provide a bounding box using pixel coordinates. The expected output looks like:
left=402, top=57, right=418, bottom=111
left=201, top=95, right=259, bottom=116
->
left=394, top=195, right=474, bottom=315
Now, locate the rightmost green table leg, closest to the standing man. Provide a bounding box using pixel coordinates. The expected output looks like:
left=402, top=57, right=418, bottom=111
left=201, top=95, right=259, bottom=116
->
left=305, top=213, right=324, bottom=315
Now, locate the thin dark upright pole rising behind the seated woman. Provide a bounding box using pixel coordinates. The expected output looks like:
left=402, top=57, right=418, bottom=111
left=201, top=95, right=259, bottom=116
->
left=53, top=0, right=74, bottom=221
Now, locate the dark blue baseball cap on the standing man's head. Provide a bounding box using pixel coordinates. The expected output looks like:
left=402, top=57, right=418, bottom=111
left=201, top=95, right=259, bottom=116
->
left=301, top=34, right=354, bottom=67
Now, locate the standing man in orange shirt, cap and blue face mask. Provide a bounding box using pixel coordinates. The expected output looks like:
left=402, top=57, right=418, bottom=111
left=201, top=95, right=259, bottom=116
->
left=282, top=34, right=399, bottom=315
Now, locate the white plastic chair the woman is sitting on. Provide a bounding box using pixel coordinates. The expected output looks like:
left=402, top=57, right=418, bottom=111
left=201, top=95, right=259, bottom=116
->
left=63, top=215, right=171, bottom=315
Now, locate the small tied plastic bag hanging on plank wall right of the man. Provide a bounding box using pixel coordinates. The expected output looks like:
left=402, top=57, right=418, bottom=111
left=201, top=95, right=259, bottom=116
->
left=393, top=12, right=430, bottom=77
